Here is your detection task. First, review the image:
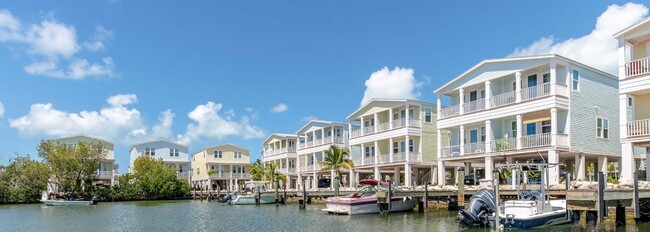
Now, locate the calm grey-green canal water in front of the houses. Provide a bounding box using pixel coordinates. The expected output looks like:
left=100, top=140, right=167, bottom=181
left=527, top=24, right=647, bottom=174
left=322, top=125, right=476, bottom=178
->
left=0, top=200, right=650, bottom=232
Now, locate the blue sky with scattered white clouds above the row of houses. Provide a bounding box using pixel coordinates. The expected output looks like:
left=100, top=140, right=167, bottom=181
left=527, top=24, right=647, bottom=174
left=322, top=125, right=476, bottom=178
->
left=0, top=0, right=648, bottom=171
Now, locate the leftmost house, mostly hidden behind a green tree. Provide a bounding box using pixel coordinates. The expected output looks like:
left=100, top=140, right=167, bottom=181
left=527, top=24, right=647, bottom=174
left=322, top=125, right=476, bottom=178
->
left=54, top=135, right=119, bottom=186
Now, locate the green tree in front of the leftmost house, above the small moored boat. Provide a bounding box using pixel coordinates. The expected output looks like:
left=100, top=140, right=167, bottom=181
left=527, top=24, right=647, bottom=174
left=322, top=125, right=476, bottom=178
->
left=38, top=140, right=106, bottom=196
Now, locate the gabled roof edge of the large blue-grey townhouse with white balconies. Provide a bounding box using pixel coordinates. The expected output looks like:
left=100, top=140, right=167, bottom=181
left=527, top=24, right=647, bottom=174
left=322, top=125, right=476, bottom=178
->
left=433, top=54, right=618, bottom=94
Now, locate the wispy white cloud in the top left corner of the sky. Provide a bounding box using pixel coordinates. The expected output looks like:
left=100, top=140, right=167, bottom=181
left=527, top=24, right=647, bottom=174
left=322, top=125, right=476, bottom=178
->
left=0, top=9, right=115, bottom=80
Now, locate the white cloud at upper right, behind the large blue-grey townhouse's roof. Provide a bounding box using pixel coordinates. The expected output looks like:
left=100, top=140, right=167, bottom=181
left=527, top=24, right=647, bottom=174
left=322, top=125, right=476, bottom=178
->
left=509, top=3, right=648, bottom=75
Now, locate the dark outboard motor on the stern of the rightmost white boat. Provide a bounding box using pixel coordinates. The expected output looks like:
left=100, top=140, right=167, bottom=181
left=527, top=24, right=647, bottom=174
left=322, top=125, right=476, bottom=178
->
left=458, top=189, right=496, bottom=227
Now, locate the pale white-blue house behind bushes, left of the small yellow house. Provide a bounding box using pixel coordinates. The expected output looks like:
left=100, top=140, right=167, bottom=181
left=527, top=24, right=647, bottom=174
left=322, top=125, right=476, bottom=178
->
left=129, top=140, right=190, bottom=180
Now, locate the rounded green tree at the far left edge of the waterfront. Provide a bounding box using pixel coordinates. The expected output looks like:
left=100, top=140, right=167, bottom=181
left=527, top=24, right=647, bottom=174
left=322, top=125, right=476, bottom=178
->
left=0, top=156, right=50, bottom=203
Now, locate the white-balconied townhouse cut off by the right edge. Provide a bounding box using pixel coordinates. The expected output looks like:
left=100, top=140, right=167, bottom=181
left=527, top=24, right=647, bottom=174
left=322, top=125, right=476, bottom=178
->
left=612, top=19, right=650, bottom=183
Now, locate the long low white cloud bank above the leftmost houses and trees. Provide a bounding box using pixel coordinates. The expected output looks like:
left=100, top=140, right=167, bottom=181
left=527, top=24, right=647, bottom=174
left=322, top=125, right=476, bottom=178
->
left=9, top=94, right=174, bottom=144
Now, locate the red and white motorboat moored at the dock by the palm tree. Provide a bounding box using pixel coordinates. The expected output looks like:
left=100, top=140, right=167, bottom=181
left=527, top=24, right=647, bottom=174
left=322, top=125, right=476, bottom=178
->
left=322, top=180, right=417, bottom=215
